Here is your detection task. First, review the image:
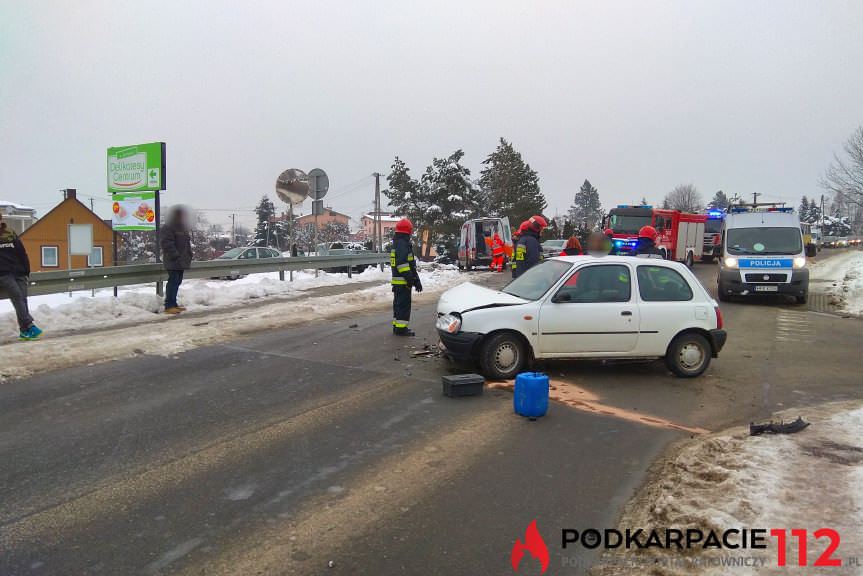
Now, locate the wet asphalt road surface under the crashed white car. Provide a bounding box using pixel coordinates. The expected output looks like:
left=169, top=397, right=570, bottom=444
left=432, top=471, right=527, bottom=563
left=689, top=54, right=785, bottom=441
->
left=0, top=258, right=863, bottom=575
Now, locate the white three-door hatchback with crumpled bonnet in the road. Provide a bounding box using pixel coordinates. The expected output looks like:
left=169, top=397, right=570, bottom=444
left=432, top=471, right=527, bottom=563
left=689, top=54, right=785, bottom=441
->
left=437, top=256, right=727, bottom=380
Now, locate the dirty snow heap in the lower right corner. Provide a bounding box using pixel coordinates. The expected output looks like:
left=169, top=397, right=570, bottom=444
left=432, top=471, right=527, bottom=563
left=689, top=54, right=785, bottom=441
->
left=593, top=402, right=863, bottom=576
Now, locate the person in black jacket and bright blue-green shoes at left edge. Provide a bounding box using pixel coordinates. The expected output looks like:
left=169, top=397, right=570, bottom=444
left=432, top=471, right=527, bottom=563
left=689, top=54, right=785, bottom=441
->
left=0, top=214, right=42, bottom=340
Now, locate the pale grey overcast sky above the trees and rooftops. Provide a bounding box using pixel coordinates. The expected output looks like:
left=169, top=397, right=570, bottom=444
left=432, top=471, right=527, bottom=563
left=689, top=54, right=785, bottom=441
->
left=0, top=0, right=863, bottom=223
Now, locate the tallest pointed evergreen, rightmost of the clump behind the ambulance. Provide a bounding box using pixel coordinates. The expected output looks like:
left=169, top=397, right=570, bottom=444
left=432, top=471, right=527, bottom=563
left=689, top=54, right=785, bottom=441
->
left=479, top=138, right=548, bottom=225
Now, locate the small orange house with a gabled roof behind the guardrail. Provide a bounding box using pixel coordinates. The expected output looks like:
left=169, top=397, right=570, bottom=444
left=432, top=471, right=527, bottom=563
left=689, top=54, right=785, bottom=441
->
left=20, top=189, right=114, bottom=272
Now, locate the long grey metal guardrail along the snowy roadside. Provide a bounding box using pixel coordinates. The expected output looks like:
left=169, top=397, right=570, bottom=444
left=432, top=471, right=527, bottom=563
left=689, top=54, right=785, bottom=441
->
left=0, top=252, right=390, bottom=298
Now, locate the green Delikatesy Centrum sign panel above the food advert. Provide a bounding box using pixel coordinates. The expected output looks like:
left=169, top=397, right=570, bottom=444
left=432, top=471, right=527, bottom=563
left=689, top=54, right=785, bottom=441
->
left=108, top=142, right=165, bottom=194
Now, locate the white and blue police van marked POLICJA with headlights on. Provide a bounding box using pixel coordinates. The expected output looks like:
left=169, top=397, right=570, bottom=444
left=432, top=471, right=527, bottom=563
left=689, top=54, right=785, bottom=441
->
left=717, top=205, right=815, bottom=304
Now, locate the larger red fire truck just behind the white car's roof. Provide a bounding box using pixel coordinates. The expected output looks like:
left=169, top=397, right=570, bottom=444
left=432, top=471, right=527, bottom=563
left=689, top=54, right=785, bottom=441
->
left=607, top=205, right=707, bottom=267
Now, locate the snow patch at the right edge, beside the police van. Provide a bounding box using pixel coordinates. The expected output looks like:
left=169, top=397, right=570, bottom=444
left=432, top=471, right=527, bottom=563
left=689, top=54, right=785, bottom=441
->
left=809, top=249, right=863, bottom=316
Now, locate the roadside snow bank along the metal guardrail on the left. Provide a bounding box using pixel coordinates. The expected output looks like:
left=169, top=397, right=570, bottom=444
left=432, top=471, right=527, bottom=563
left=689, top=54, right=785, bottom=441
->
left=0, top=267, right=466, bottom=381
